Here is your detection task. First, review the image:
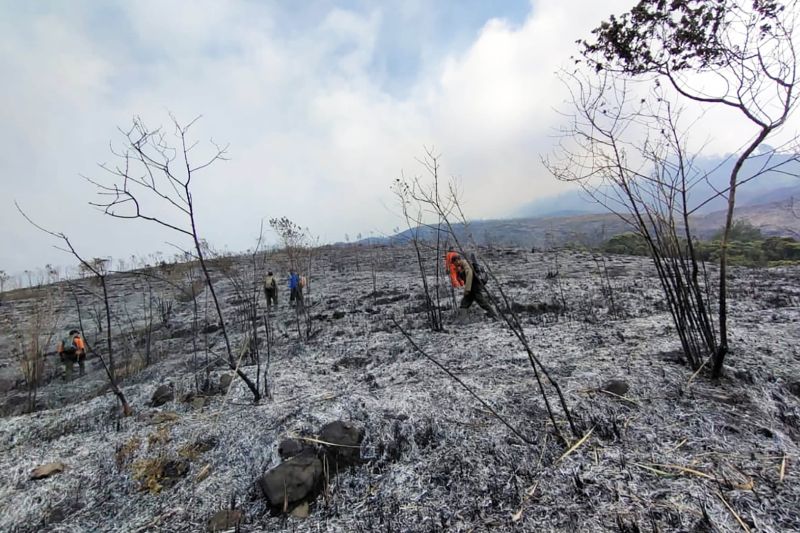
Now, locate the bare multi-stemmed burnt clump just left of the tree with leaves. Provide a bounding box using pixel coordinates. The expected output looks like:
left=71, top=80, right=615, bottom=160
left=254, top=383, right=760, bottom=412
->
left=544, top=74, right=717, bottom=369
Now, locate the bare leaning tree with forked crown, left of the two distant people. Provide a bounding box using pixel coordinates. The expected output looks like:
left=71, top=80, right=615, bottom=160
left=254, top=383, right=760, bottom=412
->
left=86, top=115, right=260, bottom=402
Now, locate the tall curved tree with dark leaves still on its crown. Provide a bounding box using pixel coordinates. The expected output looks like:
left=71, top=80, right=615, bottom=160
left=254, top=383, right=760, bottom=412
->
left=578, top=0, right=798, bottom=376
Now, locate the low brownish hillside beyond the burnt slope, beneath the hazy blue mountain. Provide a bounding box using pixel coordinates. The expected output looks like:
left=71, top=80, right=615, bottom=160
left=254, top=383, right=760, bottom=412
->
left=388, top=197, right=800, bottom=248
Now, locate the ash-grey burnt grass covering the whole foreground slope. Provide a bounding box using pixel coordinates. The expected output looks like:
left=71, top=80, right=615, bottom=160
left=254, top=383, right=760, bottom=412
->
left=0, top=246, right=800, bottom=532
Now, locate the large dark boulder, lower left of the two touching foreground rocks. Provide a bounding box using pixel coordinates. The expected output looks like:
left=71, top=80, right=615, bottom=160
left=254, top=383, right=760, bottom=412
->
left=257, top=451, right=322, bottom=511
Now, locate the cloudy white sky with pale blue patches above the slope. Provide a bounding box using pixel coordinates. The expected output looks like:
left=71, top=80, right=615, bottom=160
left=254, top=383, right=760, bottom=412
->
left=0, top=0, right=792, bottom=280
